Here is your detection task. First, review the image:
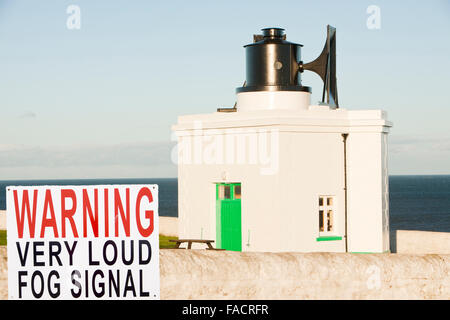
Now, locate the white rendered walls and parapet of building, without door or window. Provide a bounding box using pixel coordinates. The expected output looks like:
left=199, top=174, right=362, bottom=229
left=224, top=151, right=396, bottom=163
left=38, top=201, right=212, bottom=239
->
left=174, top=107, right=390, bottom=252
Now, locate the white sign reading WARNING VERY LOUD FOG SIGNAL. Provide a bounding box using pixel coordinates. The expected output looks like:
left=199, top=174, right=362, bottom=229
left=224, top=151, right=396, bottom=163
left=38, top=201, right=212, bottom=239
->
left=6, top=185, right=160, bottom=299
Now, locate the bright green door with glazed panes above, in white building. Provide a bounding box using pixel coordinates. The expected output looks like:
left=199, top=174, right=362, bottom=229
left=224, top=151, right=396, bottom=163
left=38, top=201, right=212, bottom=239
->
left=216, top=183, right=242, bottom=251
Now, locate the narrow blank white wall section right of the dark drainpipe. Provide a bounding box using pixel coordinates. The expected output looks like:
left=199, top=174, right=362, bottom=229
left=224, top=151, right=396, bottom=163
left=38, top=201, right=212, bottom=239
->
left=347, top=132, right=389, bottom=252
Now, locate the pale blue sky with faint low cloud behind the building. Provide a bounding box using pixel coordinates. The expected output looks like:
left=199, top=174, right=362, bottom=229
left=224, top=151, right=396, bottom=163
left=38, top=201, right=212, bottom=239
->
left=0, top=0, right=450, bottom=180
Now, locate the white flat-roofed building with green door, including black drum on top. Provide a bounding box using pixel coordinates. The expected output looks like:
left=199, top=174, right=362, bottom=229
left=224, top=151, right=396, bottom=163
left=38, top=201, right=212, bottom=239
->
left=173, top=28, right=391, bottom=252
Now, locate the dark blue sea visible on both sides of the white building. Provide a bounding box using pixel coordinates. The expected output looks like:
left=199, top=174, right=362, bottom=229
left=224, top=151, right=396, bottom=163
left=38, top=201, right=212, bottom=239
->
left=0, top=175, right=450, bottom=234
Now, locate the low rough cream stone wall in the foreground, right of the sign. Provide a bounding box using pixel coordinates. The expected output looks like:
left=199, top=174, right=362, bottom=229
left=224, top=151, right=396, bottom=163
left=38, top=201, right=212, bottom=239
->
left=160, top=250, right=450, bottom=300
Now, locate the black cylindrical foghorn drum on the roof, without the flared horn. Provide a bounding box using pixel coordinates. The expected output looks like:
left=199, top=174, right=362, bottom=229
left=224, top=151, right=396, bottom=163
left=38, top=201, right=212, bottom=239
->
left=236, top=28, right=310, bottom=93
